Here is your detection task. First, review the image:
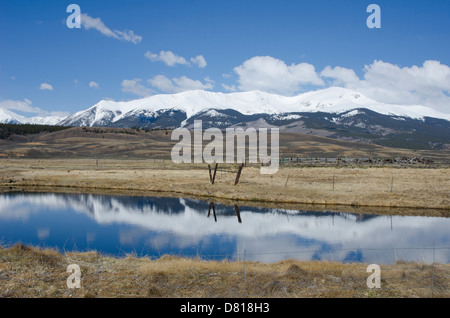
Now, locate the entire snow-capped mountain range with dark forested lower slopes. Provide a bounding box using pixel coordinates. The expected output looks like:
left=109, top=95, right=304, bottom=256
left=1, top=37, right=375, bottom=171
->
left=0, top=87, right=450, bottom=149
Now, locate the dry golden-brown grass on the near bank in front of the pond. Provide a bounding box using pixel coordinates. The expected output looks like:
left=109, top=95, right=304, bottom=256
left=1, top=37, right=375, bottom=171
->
left=0, top=244, right=450, bottom=298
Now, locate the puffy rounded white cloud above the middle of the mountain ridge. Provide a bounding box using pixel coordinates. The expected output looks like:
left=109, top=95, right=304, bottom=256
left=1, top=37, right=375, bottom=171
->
left=234, top=56, right=325, bottom=95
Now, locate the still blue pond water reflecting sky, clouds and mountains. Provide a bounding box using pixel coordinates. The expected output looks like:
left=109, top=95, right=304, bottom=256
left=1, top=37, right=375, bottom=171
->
left=0, top=193, right=450, bottom=264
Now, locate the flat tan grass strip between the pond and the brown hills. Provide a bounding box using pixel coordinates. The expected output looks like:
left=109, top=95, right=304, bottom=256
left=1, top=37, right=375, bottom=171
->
left=0, top=159, right=450, bottom=214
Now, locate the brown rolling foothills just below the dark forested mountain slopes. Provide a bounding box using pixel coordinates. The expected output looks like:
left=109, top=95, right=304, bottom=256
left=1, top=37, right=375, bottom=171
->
left=0, top=127, right=450, bottom=161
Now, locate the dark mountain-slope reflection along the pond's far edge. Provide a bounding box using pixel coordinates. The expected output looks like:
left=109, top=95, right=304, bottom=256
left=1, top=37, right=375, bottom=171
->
left=50, top=194, right=380, bottom=222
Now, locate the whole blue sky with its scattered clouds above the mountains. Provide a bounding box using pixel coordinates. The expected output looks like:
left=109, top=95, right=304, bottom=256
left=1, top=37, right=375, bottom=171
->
left=0, top=0, right=450, bottom=115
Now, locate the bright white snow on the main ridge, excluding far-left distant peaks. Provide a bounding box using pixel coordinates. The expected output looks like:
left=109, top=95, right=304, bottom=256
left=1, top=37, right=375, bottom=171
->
left=60, top=87, right=450, bottom=126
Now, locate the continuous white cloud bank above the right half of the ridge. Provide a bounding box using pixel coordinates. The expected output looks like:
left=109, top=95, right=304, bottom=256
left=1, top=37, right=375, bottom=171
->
left=228, top=56, right=450, bottom=113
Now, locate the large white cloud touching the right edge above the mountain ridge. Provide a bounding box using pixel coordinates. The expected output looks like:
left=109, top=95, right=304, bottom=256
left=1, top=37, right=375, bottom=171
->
left=321, top=60, right=450, bottom=113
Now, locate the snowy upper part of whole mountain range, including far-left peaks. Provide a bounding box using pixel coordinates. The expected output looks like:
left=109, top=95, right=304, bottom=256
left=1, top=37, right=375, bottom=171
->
left=0, top=87, right=450, bottom=127
